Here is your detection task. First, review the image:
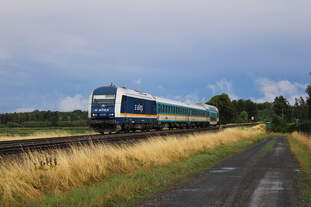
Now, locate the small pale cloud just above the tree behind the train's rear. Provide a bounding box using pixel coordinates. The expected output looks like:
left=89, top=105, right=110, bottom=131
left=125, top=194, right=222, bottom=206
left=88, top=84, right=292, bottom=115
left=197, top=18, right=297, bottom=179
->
left=207, top=79, right=238, bottom=100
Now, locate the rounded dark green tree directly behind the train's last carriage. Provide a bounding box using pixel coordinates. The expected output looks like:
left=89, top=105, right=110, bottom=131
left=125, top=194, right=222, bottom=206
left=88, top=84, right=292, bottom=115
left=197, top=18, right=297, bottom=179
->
left=206, top=93, right=235, bottom=124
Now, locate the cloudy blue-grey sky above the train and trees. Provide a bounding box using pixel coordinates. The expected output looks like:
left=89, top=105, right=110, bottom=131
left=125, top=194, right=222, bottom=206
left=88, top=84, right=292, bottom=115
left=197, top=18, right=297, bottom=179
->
left=0, top=0, right=311, bottom=113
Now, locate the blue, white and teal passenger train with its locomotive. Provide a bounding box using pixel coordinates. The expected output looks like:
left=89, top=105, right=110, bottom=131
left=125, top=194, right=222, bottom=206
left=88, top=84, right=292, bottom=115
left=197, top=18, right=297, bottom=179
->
left=88, top=84, right=219, bottom=133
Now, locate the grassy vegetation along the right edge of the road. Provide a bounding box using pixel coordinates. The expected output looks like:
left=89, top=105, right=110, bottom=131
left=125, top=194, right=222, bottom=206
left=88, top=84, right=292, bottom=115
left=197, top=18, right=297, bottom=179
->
left=289, top=132, right=311, bottom=205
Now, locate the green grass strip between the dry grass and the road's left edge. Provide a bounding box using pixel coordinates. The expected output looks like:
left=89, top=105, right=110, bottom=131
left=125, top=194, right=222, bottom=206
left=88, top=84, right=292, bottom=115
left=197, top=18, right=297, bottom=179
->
left=32, top=135, right=266, bottom=207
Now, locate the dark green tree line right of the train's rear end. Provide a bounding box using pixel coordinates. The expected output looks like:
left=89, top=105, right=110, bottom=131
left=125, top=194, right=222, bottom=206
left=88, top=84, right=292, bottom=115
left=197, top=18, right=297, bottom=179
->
left=206, top=77, right=311, bottom=132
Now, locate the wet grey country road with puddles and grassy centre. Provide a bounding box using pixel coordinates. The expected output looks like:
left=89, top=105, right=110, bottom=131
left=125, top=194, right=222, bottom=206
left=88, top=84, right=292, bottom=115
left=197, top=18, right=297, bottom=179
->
left=141, top=137, right=300, bottom=207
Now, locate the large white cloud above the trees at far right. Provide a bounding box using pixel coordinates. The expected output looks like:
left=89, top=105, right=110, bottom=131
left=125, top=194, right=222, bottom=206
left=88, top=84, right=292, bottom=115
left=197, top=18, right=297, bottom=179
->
left=255, top=78, right=307, bottom=104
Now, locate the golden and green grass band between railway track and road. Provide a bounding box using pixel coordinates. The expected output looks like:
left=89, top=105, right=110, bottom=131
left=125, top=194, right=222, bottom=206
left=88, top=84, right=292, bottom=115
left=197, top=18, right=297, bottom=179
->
left=0, top=126, right=266, bottom=206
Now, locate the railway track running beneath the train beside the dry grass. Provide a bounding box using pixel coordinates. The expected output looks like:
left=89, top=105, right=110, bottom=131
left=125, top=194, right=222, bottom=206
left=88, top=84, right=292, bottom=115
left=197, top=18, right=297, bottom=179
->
left=0, top=123, right=258, bottom=157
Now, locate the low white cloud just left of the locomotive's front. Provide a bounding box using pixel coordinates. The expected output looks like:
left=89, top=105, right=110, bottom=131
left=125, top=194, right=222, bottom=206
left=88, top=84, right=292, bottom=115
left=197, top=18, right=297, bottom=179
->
left=58, top=94, right=89, bottom=111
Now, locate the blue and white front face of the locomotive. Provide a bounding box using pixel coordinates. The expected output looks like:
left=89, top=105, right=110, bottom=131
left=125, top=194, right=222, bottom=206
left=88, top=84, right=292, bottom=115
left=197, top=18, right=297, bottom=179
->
left=89, top=85, right=117, bottom=132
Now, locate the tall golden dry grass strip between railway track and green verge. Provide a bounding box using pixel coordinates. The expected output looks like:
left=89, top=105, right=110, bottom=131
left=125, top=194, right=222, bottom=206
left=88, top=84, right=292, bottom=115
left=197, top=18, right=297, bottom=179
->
left=0, top=127, right=263, bottom=206
